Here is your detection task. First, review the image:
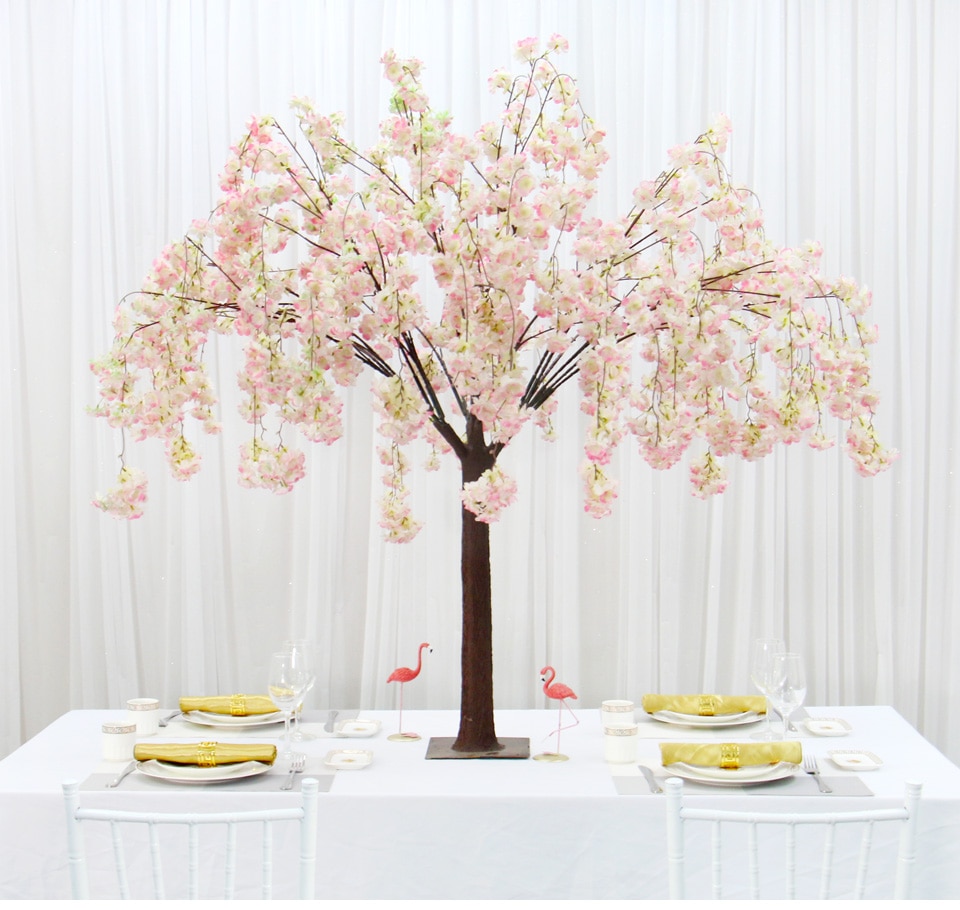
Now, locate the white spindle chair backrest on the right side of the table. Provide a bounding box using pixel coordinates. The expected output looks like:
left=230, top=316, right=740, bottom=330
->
left=665, top=777, right=922, bottom=900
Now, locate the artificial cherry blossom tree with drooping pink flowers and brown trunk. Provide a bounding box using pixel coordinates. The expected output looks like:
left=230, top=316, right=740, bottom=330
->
left=93, top=36, right=893, bottom=753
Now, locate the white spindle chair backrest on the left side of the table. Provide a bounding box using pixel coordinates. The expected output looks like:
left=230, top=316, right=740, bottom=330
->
left=62, top=777, right=318, bottom=900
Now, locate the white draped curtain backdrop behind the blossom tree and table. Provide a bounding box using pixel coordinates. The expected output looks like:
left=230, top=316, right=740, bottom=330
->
left=0, top=0, right=960, bottom=761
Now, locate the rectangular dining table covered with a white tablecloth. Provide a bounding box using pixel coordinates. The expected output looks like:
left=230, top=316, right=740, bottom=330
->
left=0, top=706, right=960, bottom=899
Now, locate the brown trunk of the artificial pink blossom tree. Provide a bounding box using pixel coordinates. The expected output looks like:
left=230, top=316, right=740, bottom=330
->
left=452, top=417, right=503, bottom=752
